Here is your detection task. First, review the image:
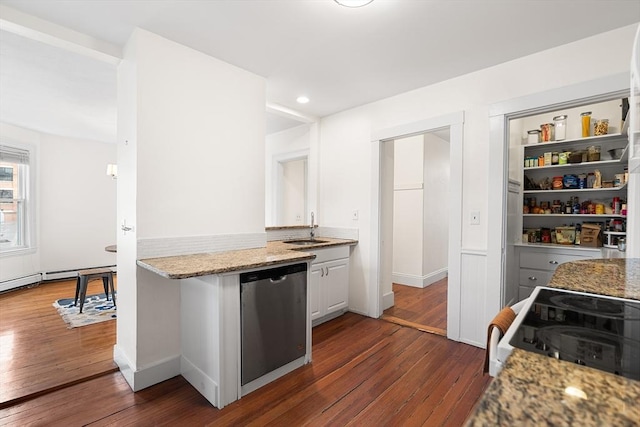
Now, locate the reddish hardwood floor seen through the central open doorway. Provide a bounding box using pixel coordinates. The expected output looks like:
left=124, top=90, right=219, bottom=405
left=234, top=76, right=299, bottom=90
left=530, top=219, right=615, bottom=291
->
left=383, top=277, right=447, bottom=336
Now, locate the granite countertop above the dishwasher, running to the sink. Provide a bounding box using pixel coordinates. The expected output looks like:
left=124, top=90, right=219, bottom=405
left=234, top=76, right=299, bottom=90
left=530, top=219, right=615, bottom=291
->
left=137, top=237, right=358, bottom=279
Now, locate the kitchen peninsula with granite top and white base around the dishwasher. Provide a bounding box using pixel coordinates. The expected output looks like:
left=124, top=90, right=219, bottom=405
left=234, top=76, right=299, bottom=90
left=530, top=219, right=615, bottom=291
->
left=137, top=237, right=357, bottom=409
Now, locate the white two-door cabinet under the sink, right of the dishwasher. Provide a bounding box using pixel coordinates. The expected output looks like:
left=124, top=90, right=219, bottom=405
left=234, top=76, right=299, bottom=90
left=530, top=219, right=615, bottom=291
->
left=308, top=246, right=349, bottom=326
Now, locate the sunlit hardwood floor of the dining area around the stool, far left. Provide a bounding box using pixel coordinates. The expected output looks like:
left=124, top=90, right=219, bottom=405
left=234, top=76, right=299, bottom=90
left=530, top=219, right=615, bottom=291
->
left=0, top=279, right=117, bottom=408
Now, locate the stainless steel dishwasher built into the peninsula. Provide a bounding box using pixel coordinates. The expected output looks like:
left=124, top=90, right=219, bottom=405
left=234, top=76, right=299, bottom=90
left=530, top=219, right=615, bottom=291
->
left=240, top=264, right=307, bottom=385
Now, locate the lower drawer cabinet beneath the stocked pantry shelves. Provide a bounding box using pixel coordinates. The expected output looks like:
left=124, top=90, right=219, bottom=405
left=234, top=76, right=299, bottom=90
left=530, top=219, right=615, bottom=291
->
left=516, top=246, right=603, bottom=301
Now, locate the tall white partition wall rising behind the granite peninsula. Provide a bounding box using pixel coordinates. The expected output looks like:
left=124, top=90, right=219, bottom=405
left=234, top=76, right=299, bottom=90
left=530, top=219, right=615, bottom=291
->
left=114, top=29, right=266, bottom=390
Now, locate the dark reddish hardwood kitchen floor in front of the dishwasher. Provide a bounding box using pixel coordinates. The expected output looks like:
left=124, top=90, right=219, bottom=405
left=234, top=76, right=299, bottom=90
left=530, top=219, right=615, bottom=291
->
left=0, top=313, right=490, bottom=426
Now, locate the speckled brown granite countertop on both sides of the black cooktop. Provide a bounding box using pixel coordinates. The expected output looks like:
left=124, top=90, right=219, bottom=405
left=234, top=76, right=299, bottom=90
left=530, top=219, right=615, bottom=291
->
left=466, top=259, right=640, bottom=426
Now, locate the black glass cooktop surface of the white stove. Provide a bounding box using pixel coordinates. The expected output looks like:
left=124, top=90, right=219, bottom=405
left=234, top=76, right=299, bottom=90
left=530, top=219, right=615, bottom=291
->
left=509, top=289, right=640, bottom=380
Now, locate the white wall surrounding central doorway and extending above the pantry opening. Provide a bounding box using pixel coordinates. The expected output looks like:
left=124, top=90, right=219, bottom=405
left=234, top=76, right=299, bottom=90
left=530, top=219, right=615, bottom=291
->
left=319, top=25, right=636, bottom=343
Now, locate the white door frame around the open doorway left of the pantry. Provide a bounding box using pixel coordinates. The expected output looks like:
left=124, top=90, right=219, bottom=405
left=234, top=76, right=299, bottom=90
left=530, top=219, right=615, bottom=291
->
left=369, top=111, right=464, bottom=341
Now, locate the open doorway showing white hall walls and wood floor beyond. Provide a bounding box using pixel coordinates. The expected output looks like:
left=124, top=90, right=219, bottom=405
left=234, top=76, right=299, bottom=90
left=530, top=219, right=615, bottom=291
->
left=382, top=127, right=450, bottom=336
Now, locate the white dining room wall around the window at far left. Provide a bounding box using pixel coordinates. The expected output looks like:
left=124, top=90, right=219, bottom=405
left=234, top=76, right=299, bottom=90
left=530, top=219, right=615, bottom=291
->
left=0, top=123, right=116, bottom=281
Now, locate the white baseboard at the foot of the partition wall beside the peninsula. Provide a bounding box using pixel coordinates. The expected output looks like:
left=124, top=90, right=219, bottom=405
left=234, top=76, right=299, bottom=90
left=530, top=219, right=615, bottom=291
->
left=113, top=344, right=180, bottom=392
